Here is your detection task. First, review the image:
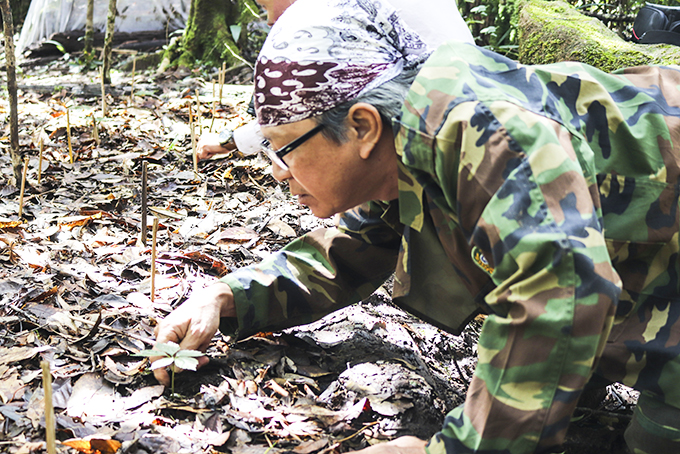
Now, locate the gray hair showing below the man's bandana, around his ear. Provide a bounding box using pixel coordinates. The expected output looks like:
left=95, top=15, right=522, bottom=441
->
left=315, top=68, right=420, bottom=144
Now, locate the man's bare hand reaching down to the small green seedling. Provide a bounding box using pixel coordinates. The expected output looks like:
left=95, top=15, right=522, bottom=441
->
left=149, top=282, right=236, bottom=386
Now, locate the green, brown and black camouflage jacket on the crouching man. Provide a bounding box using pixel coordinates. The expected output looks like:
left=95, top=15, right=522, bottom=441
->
left=225, top=43, right=680, bottom=454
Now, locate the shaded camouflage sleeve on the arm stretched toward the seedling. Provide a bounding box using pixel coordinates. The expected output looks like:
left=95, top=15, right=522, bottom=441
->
left=220, top=202, right=401, bottom=337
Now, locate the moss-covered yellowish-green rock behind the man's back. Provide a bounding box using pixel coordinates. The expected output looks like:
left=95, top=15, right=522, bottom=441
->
left=517, top=0, right=680, bottom=72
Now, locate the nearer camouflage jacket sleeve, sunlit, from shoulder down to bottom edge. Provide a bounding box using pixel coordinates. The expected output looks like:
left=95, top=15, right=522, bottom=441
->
left=420, top=102, right=620, bottom=454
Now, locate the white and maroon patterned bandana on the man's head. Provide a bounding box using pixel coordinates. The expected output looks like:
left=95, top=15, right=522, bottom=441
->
left=255, top=0, right=430, bottom=126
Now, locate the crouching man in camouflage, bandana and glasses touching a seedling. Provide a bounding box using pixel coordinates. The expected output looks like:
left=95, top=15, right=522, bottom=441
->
left=157, top=0, right=680, bottom=454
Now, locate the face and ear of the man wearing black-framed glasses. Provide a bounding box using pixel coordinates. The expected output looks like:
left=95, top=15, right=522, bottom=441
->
left=262, top=103, right=398, bottom=218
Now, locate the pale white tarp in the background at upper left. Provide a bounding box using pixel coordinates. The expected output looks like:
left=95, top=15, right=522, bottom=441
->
left=17, top=0, right=191, bottom=52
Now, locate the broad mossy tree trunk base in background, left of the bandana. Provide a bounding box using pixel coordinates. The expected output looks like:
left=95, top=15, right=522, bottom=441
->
left=161, top=0, right=257, bottom=69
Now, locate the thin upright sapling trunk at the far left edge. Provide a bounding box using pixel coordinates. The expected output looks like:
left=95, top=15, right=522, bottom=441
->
left=0, top=0, right=22, bottom=185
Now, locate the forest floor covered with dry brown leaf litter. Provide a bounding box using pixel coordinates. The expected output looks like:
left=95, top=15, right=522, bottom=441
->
left=0, top=51, right=635, bottom=454
